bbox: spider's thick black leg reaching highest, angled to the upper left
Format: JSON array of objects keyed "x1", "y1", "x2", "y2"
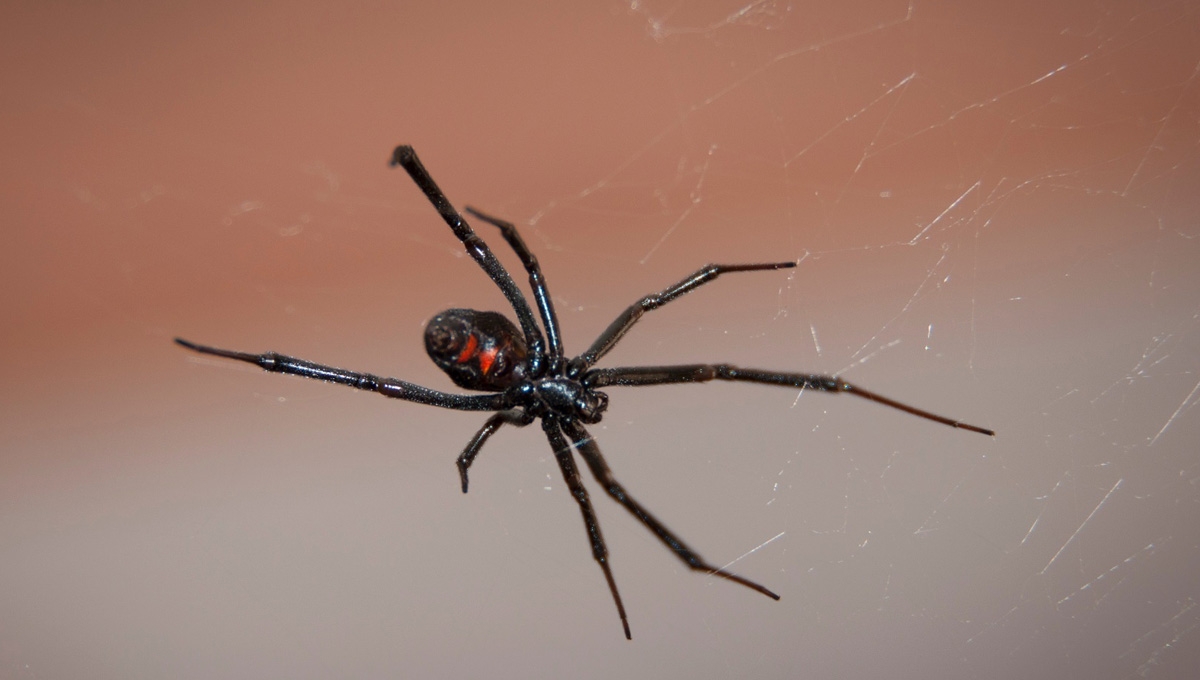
[{"x1": 391, "y1": 144, "x2": 545, "y2": 375}]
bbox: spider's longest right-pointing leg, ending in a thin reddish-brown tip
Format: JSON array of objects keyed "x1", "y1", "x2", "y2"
[{"x1": 582, "y1": 363, "x2": 996, "y2": 437}]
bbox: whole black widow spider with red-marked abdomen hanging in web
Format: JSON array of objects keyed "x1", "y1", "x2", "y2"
[{"x1": 175, "y1": 145, "x2": 995, "y2": 639}]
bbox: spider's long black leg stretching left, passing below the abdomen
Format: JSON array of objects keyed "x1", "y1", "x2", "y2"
[{"x1": 175, "y1": 338, "x2": 512, "y2": 411}]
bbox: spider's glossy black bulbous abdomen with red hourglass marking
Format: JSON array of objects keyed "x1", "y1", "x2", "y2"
[{"x1": 425, "y1": 309, "x2": 528, "y2": 392}]
